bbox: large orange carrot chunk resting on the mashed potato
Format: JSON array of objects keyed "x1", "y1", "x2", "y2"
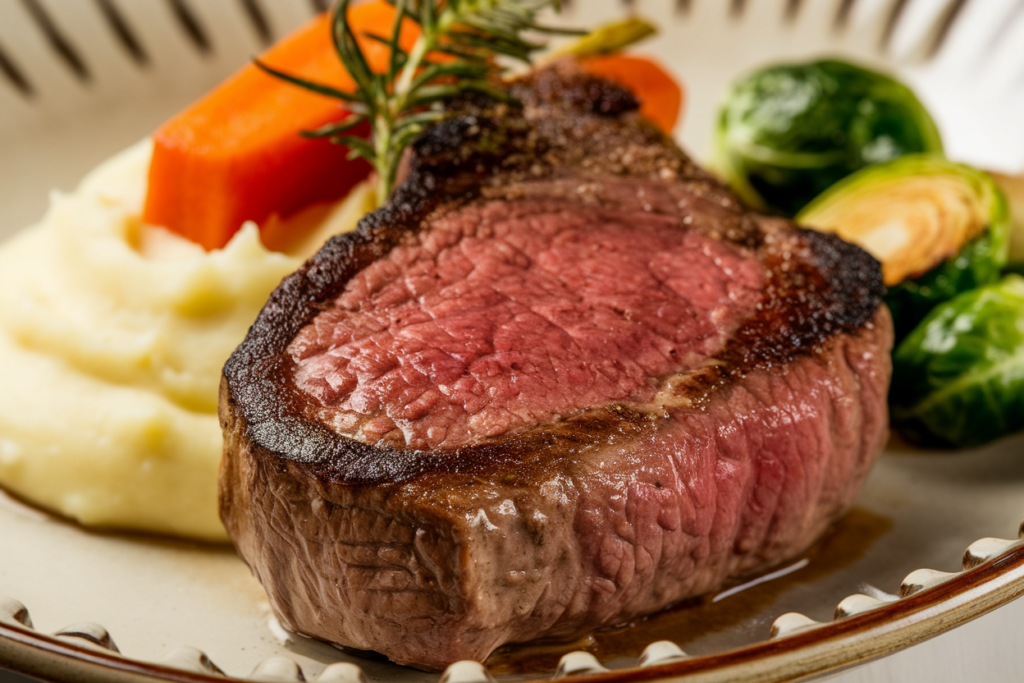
[{"x1": 142, "y1": 0, "x2": 416, "y2": 250}]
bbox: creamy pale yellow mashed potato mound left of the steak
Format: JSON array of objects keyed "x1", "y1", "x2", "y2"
[{"x1": 0, "y1": 142, "x2": 373, "y2": 541}]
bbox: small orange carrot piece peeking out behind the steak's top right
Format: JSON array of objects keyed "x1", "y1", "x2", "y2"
[{"x1": 580, "y1": 54, "x2": 683, "y2": 133}]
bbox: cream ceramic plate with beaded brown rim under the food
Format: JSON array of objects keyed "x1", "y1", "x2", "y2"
[{"x1": 0, "y1": 0, "x2": 1024, "y2": 683}]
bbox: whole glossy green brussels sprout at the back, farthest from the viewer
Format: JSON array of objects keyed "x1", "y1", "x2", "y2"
[{"x1": 715, "y1": 60, "x2": 942, "y2": 216}]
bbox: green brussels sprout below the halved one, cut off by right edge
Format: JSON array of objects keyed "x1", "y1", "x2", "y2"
[{"x1": 889, "y1": 274, "x2": 1024, "y2": 446}]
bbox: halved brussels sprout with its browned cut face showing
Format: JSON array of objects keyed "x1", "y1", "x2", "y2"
[{"x1": 797, "y1": 155, "x2": 1010, "y2": 339}]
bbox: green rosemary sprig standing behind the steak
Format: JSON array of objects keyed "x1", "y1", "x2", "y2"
[{"x1": 256, "y1": 0, "x2": 580, "y2": 204}]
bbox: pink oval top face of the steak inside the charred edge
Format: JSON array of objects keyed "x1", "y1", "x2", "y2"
[{"x1": 289, "y1": 200, "x2": 766, "y2": 449}]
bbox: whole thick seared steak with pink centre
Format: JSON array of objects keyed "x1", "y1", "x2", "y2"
[{"x1": 220, "y1": 62, "x2": 892, "y2": 669}]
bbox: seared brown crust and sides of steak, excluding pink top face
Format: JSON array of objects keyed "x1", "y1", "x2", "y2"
[{"x1": 221, "y1": 63, "x2": 891, "y2": 668}]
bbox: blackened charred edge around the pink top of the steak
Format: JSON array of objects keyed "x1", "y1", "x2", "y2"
[{"x1": 221, "y1": 60, "x2": 885, "y2": 484}]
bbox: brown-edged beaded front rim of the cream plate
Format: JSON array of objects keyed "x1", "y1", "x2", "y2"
[{"x1": 6, "y1": 539, "x2": 1024, "y2": 683}]
